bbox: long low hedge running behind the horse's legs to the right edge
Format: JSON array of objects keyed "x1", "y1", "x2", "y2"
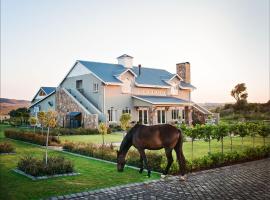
[{"x1": 63, "y1": 142, "x2": 270, "y2": 174}]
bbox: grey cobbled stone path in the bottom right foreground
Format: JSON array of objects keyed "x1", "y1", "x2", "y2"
[{"x1": 48, "y1": 158, "x2": 270, "y2": 200}]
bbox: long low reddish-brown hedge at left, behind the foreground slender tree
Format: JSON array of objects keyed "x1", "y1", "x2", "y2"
[{"x1": 4, "y1": 129, "x2": 60, "y2": 146}]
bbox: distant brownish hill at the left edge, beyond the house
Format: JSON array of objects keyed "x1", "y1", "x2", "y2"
[{"x1": 0, "y1": 98, "x2": 31, "y2": 115}]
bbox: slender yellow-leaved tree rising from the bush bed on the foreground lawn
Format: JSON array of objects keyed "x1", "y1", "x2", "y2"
[{"x1": 45, "y1": 110, "x2": 57, "y2": 165}]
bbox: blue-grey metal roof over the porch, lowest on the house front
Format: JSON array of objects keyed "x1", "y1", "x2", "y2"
[{"x1": 133, "y1": 95, "x2": 191, "y2": 104}]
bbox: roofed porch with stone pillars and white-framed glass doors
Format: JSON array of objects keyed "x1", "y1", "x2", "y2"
[{"x1": 132, "y1": 96, "x2": 193, "y2": 125}]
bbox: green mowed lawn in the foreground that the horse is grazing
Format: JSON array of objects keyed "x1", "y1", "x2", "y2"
[{"x1": 0, "y1": 127, "x2": 159, "y2": 200}]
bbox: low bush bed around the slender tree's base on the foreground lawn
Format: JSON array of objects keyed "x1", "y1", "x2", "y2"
[{"x1": 17, "y1": 156, "x2": 74, "y2": 177}]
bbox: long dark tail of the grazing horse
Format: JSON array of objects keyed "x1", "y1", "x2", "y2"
[{"x1": 176, "y1": 128, "x2": 186, "y2": 176}]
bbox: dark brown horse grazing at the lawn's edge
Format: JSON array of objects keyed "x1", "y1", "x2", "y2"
[{"x1": 117, "y1": 124, "x2": 186, "y2": 177}]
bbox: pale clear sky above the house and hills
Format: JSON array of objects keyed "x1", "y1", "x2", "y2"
[{"x1": 1, "y1": 0, "x2": 270, "y2": 103}]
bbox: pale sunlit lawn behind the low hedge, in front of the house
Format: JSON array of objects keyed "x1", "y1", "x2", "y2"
[{"x1": 60, "y1": 130, "x2": 270, "y2": 160}]
